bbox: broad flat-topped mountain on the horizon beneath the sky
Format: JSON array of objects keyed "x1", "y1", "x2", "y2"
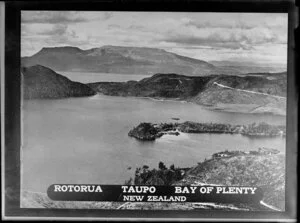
[{"x1": 22, "y1": 46, "x2": 239, "y2": 76}]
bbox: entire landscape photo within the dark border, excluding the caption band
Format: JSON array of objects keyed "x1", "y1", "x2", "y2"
[{"x1": 20, "y1": 10, "x2": 288, "y2": 212}]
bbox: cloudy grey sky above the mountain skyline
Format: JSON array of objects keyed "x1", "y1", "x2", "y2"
[{"x1": 21, "y1": 11, "x2": 288, "y2": 65}]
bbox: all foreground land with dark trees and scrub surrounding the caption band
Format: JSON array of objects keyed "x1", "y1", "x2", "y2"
[{"x1": 21, "y1": 148, "x2": 285, "y2": 211}]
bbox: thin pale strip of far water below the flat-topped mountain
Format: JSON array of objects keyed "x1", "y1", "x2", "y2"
[{"x1": 57, "y1": 71, "x2": 152, "y2": 83}]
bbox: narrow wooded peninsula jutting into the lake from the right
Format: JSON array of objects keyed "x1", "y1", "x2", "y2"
[{"x1": 128, "y1": 122, "x2": 286, "y2": 141}]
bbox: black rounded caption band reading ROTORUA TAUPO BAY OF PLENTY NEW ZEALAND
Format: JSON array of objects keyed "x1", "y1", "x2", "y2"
[{"x1": 47, "y1": 184, "x2": 263, "y2": 203}]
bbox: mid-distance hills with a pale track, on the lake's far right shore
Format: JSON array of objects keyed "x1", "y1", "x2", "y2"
[{"x1": 87, "y1": 73, "x2": 287, "y2": 115}]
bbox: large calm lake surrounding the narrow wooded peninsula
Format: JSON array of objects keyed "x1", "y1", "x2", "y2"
[{"x1": 21, "y1": 95, "x2": 285, "y2": 192}]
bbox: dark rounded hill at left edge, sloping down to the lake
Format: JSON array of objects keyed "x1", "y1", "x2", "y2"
[{"x1": 21, "y1": 65, "x2": 95, "y2": 99}]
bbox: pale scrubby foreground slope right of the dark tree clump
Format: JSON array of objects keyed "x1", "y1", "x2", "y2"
[{"x1": 178, "y1": 154, "x2": 285, "y2": 210}]
